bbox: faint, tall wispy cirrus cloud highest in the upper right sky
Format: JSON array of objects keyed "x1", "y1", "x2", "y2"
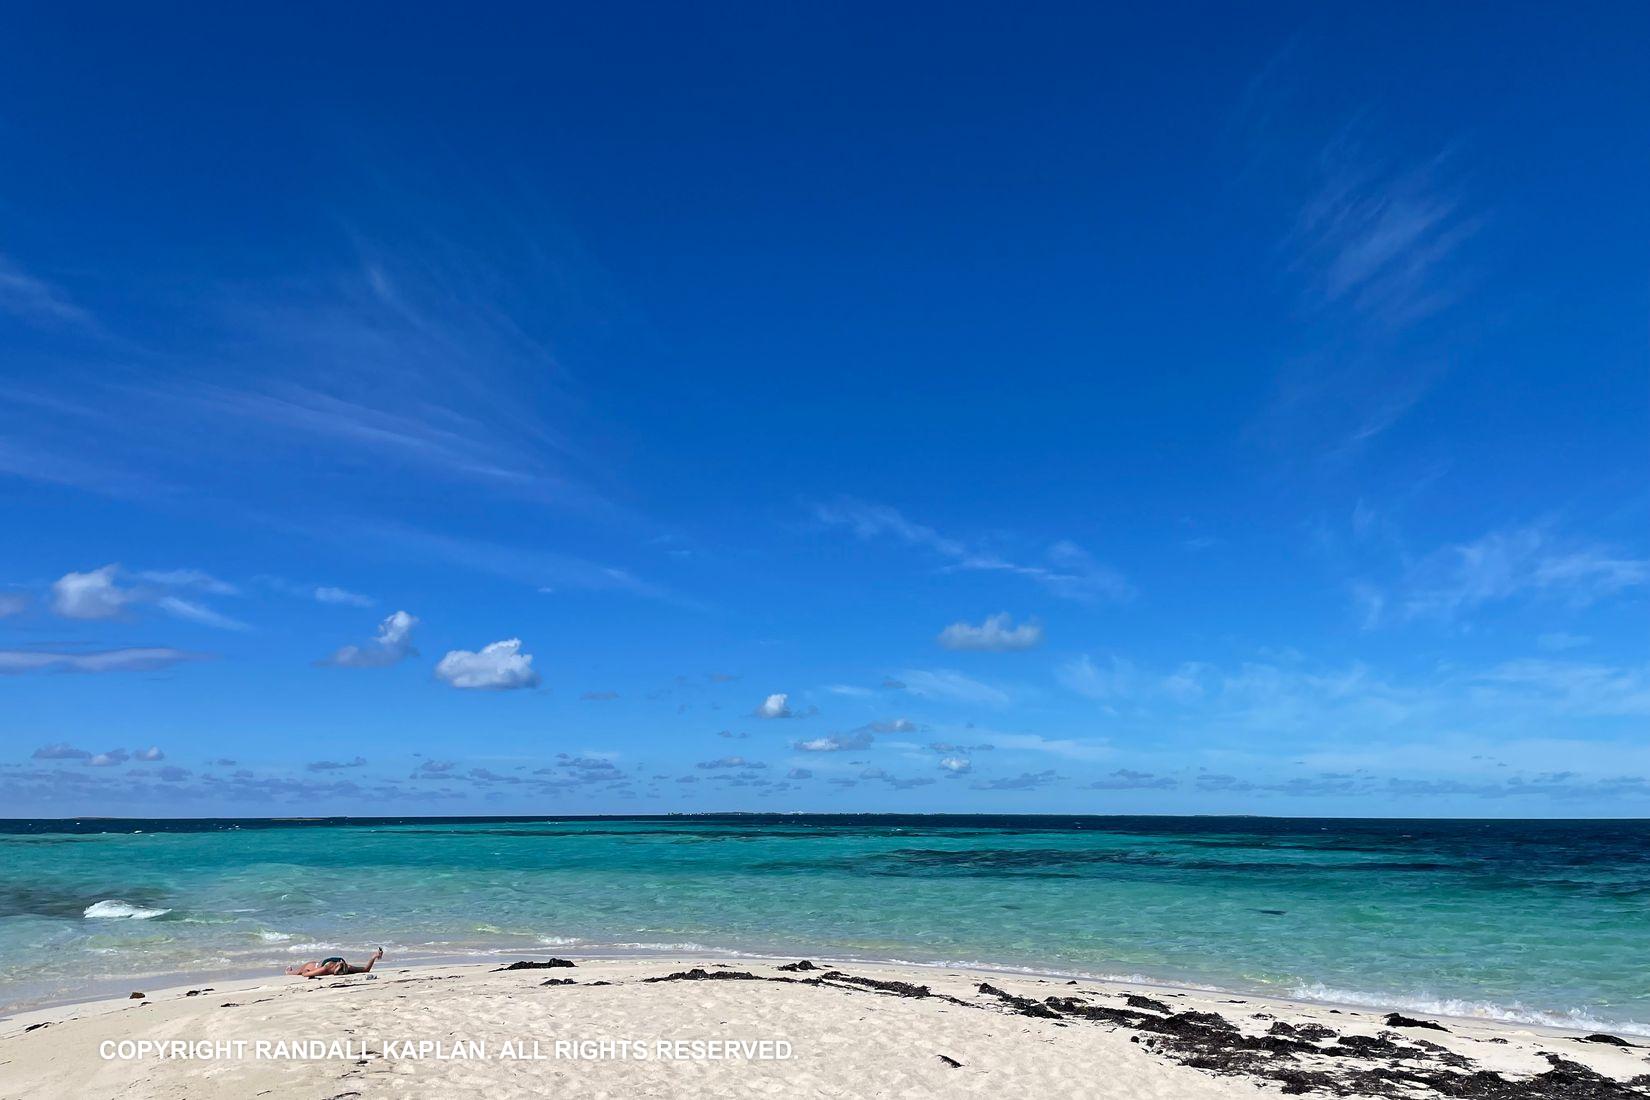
[{"x1": 1234, "y1": 49, "x2": 1490, "y2": 465}]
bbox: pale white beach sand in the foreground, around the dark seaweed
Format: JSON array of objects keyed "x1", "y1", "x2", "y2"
[{"x1": 0, "y1": 958, "x2": 1650, "y2": 1100}]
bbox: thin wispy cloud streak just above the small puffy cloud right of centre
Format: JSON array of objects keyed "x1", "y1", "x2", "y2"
[{"x1": 813, "y1": 496, "x2": 1134, "y2": 600}]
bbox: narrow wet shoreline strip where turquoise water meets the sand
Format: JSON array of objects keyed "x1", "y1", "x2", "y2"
[{"x1": 0, "y1": 943, "x2": 1650, "y2": 1047}]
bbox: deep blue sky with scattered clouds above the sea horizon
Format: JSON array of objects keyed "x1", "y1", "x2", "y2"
[{"x1": 0, "y1": 5, "x2": 1650, "y2": 816}]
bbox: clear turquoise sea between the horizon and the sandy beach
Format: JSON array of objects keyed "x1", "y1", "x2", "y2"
[{"x1": 0, "y1": 816, "x2": 1650, "y2": 1034}]
